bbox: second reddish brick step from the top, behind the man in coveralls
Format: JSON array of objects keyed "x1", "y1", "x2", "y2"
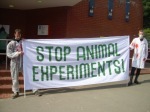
[{"x1": 0, "y1": 77, "x2": 24, "y2": 85}]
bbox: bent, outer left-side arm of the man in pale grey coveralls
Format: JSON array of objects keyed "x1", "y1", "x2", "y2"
[{"x1": 6, "y1": 41, "x2": 21, "y2": 59}]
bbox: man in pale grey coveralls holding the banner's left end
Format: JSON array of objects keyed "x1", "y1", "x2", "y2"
[{"x1": 6, "y1": 29, "x2": 41, "y2": 99}]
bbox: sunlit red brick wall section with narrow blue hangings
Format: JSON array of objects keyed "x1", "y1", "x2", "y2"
[{"x1": 67, "y1": 0, "x2": 143, "y2": 38}]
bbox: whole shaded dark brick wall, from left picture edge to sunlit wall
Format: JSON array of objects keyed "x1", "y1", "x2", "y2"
[{"x1": 0, "y1": 7, "x2": 68, "y2": 38}]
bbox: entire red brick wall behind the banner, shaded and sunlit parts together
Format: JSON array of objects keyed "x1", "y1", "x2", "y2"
[{"x1": 0, "y1": 0, "x2": 143, "y2": 38}]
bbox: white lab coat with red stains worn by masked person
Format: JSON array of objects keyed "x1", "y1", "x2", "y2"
[{"x1": 130, "y1": 38, "x2": 148, "y2": 68}]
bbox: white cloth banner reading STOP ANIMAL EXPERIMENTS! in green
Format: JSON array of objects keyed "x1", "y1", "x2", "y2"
[{"x1": 23, "y1": 36, "x2": 129, "y2": 90}]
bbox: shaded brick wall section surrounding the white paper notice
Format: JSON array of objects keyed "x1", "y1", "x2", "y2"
[{"x1": 26, "y1": 7, "x2": 68, "y2": 38}]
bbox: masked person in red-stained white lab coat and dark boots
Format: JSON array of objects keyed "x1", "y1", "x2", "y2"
[{"x1": 128, "y1": 30, "x2": 148, "y2": 86}]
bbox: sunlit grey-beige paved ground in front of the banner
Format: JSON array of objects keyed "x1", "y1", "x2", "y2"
[{"x1": 0, "y1": 75, "x2": 150, "y2": 112}]
